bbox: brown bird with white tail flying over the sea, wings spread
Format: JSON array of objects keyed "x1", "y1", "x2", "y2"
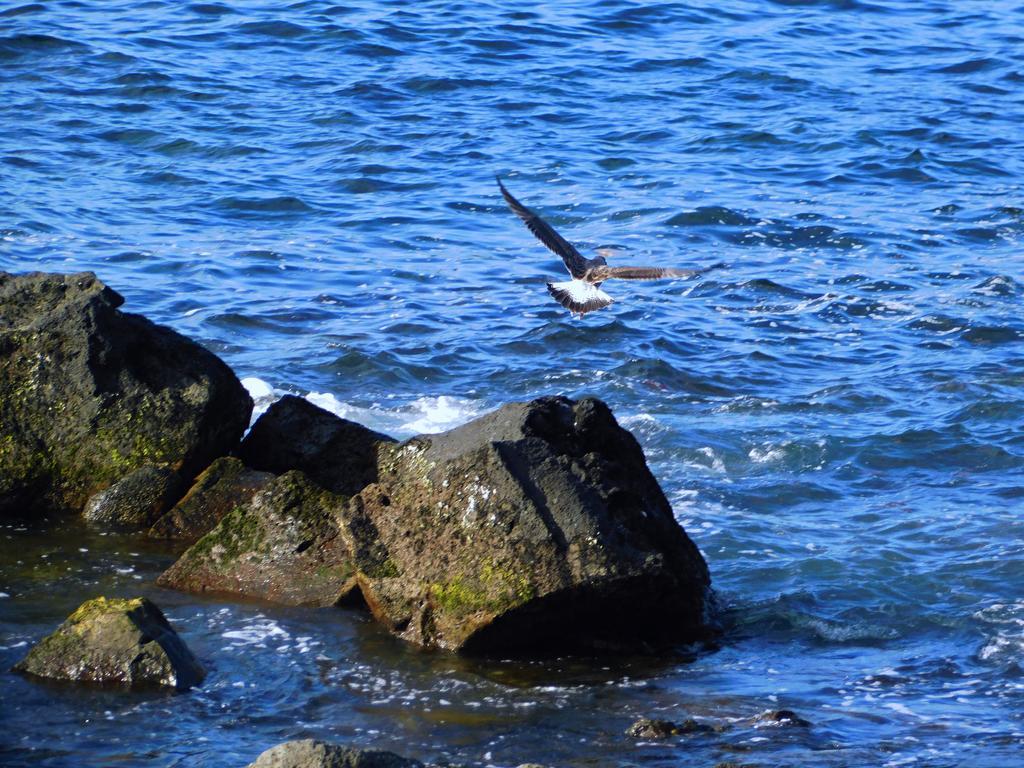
[{"x1": 495, "y1": 176, "x2": 707, "y2": 317}]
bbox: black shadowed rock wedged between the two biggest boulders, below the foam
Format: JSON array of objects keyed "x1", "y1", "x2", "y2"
[{"x1": 238, "y1": 395, "x2": 394, "y2": 496}]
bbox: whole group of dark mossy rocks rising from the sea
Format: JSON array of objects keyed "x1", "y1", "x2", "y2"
[{"x1": 0, "y1": 273, "x2": 715, "y2": 765}]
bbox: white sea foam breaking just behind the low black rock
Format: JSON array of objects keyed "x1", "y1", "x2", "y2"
[{"x1": 242, "y1": 377, "x2": 486, "y2": 438}]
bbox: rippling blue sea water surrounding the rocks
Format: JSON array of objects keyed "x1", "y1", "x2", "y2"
[{"x1": 0, "y1": 0, "x2": 1024, "y2": 768}]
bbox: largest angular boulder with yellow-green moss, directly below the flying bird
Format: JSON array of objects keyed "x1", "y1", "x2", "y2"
[{"x1": 364, "y1": 397, "x2": 710, "y2": 654}]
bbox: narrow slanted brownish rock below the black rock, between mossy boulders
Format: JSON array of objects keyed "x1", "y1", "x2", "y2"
[{"x1": 148, "y1": 457, "x2": 273, "y2": 542}]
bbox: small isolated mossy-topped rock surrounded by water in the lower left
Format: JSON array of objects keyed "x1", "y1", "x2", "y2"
[{"x1": 14, "y1": 597, "x2": 206, "y2": 690}]
